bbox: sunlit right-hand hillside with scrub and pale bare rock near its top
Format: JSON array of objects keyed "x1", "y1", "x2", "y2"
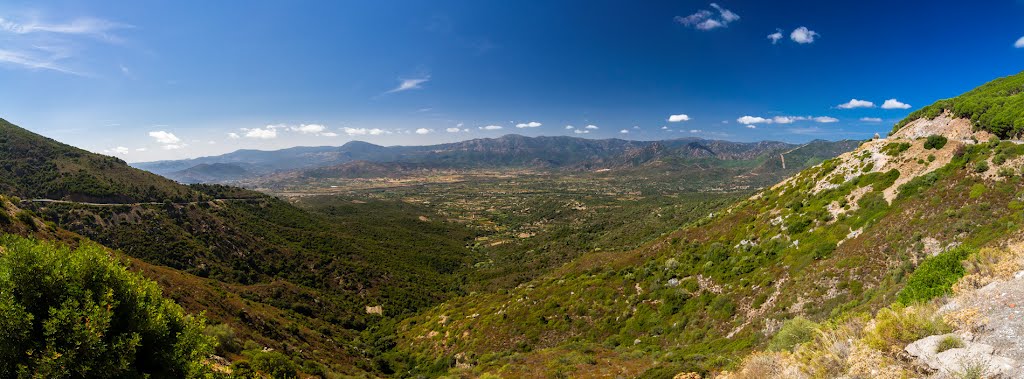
[{"x1": 391, "y1": 75, "x2": 1024, "y2": 377}]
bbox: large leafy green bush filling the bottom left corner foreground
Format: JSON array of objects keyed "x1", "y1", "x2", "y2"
[{"x1": 0, "y1": 236, "x2": 212, "y2": 378}]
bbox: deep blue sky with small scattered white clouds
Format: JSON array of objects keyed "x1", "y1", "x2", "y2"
[{"x1": 0, "y1": 0, "x2": 1024, "y2": 162}]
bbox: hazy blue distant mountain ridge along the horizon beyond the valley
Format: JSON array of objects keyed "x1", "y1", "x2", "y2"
[{"x1": 133, "y1": 134, "x2": 855, "y2": 182}]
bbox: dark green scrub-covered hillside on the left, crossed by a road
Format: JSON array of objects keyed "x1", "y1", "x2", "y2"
[{"x1": 0, "y1": 118, "x2": 481, "y2": 374}]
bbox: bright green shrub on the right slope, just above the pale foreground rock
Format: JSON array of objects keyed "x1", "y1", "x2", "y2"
[{"x1": 897, "y1": 248, "x2": 973, "y2": 304}]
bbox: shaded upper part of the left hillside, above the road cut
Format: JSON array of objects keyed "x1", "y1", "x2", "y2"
[{"x1": 0, "y1": 119, "x2": 199, "y2": 202}]
